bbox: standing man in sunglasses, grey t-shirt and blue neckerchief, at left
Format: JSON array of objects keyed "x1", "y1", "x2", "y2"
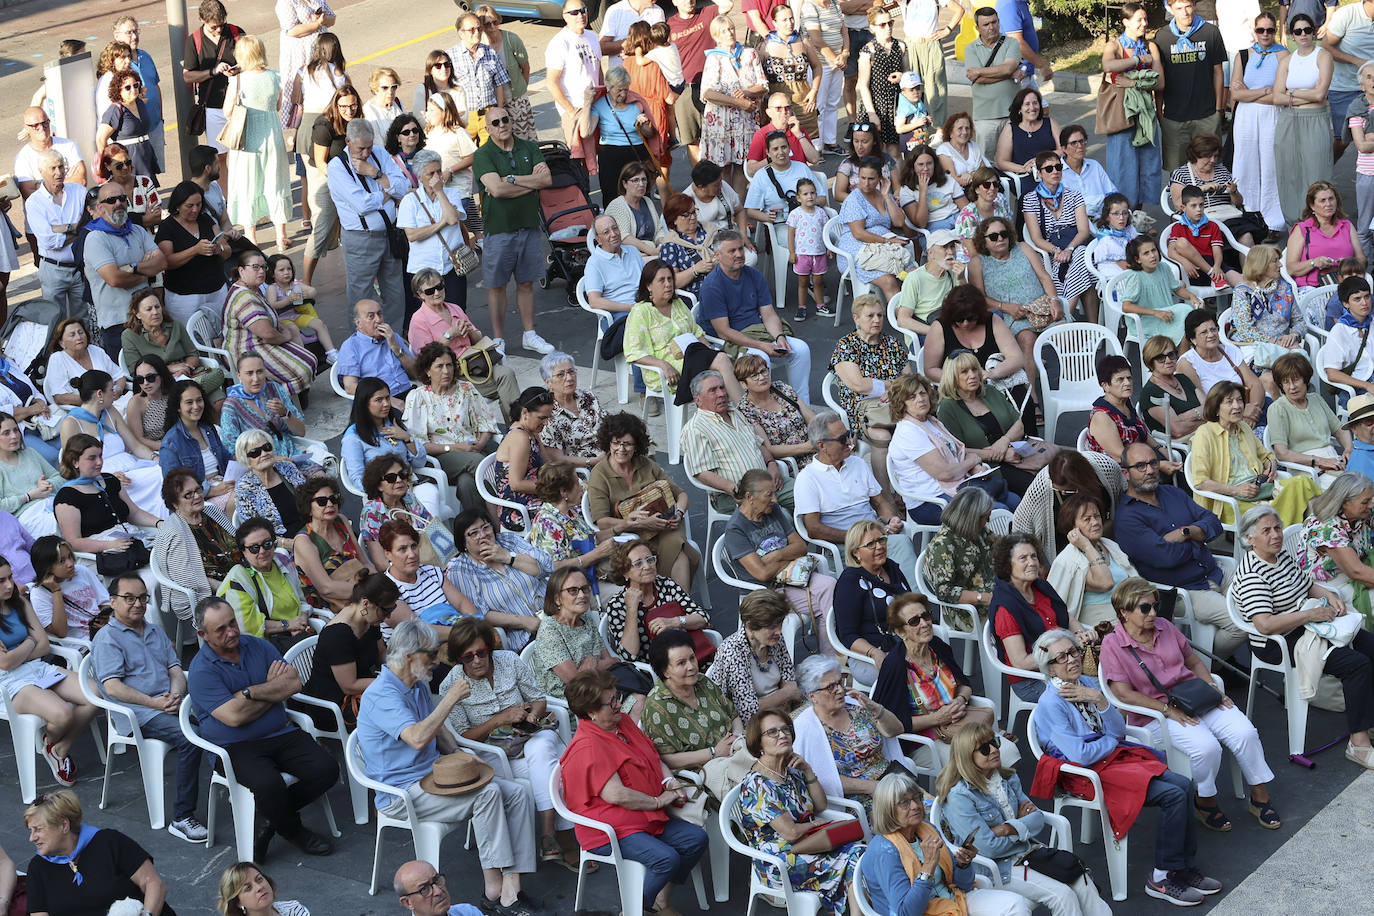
[{"x1": 84, "y1": 181, "x2": 168, "y2": 353}]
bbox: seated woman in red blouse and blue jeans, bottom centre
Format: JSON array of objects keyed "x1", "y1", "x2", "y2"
[{"x1": 561, "y1": 670, "x2": 709, "y2": 915}]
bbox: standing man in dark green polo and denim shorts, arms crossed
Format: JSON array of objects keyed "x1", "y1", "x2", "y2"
[{"x1": 473, "y1": 106, "x2": 554, "y2": 356}]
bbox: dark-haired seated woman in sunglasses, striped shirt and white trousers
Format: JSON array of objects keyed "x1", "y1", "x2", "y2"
[{"x1": 438, "y1": 617, "x2": 579, "y2": 872}]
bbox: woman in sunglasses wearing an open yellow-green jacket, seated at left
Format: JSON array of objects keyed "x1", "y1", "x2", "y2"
[{"x1": 216, "y1": 518, "x2": 313, "y2": 652}]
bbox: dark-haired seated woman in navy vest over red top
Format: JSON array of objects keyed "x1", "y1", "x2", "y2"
[{"x1": 991, "y1": 531, "x2": 1069, "y2": 700}]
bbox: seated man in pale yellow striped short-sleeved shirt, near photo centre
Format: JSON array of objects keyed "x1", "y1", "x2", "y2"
[{"x1": 682, "y1": 369, "x2": 793, "y2": 514}]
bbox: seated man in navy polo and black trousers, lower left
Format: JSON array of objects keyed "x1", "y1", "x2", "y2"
[{"x1": 190, "y1": 597, "x2": 339, "y2": 864}]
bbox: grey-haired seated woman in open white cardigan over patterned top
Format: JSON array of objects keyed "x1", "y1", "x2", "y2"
[{"x1": 796, "y1": 655, "x2": 914, "y2": 810}]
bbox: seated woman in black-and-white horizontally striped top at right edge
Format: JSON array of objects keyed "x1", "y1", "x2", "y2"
[{"x1": 1231, "y1": 505, "x2": 1374, "y2": 769}]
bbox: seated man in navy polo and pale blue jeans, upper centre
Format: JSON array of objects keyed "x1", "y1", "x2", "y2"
[{"x1": 701, "y1": 229, "x2": 811, "y2": 404}]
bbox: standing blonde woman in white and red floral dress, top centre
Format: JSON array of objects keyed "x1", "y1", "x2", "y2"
[{"x1": 701, "y1": 16, "x2": 768, "y2": 192}]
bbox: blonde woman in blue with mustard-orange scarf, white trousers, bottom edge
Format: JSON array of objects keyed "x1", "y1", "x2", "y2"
[{"x1": 859, "y1": 773, "x2": 1031, "y2": 916}]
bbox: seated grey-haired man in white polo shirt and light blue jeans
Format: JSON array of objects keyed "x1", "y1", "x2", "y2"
[{"x1": 793, "y1": 411, "x2": 916, "y2": 582}]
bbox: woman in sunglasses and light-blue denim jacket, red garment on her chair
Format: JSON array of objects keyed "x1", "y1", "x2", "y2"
[{"x1": 1031, "y1": 629, "x2": 1221, "y2": 906}]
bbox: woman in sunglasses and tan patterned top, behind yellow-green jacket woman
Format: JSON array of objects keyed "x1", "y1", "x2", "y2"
[{"x1": 291, "y1": 477, "x2": 372, "y2": 611}]
